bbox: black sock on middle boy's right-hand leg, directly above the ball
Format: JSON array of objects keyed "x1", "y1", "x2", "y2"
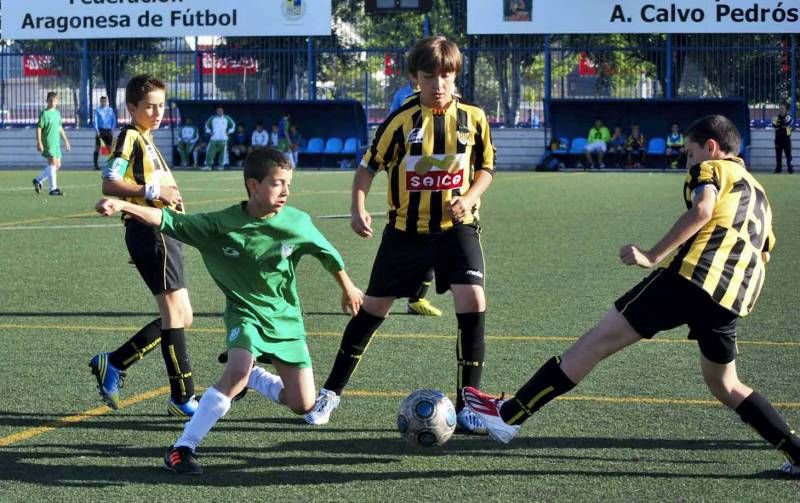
[{"x1": 456, "y1": 313, "x2": 486, "y2": 411}]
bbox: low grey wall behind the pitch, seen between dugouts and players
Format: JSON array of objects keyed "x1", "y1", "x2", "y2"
[{"x1": 0, "y1": 128, "x2": 788, "y2": 170}]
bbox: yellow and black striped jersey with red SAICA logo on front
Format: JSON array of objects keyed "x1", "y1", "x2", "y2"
[{"x1": 361, "y1": 93, "x2": 495, "y2": 233}]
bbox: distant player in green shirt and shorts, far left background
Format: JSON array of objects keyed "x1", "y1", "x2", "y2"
[{"x1": 33, "y1": 91, "x2": 72, "y2": 196}]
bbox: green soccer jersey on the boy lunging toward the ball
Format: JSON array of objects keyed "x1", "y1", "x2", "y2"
[{"x1": 161, "y1": 202, "x2": 344, "y2": 340}]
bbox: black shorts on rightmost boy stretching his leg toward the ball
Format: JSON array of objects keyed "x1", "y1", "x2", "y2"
[{"x1": 614, "y1": 269, "x2": 739, "y2": 364}]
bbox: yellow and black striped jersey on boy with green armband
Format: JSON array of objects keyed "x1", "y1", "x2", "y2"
[{"x1": 103, "y1": 125, "x2": 184, "y2": 213}]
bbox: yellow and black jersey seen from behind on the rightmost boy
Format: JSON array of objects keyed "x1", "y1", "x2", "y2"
[{"x1": 669, "y1": 158, "x2": 775, "y2": 316}]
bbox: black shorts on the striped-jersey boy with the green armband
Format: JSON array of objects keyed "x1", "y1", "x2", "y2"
[{"x1": 125, "y1": 219, "x2": 186, "y2": 295}]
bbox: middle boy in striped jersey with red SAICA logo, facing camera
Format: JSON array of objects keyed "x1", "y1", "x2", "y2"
[{"x1": 306, "y1": 37, "x2": 495, "y2": 434}]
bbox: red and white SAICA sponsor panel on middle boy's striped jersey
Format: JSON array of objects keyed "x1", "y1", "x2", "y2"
[{"x1": 406, "y1": 154, "x2": 465, "y2": 192}]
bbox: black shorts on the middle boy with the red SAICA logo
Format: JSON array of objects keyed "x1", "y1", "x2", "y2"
[{"x1": 367, "y1": 224, "x2": 485, "y2": 297}]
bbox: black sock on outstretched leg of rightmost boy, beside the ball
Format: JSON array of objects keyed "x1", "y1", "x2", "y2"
[{"x1": 500, "y1": 356, "x2": 575, "y2": 424}]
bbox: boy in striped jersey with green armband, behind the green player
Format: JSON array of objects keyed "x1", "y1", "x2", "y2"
[{"x1": 89, "y1": 75, "x2": 197, "y2": 417}]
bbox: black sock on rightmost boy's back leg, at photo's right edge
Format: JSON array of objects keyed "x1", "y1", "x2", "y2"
[{"x1": 736, "y1": 391, "x2": 800, "y2": 466}]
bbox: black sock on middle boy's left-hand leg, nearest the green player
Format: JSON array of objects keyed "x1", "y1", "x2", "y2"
[{"x1": 323, "y1": 308, "x2": 385, "y2": 395}]
